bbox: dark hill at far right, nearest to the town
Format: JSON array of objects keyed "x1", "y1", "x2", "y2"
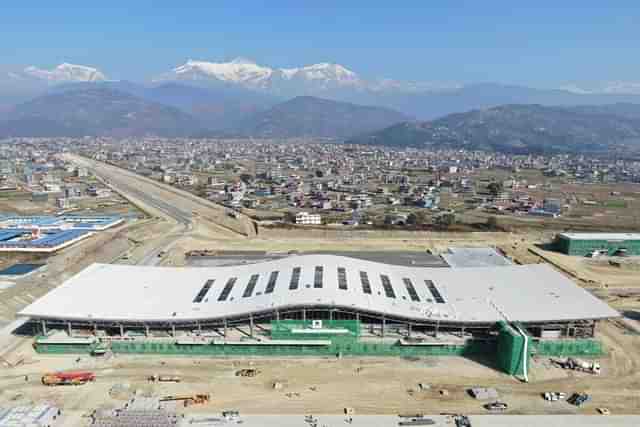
[{"x1": 348, "y1": 104, "x2": 640, "y2": 153}]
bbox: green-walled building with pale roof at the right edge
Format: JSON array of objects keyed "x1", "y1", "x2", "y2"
[{"x1": 553, "y1": 233, "x2": 640, "y2": 256}]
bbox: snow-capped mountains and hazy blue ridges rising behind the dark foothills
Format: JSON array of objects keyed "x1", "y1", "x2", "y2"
[{"x1": 8, "y1": 58, "x2": 640, "y2": 120}]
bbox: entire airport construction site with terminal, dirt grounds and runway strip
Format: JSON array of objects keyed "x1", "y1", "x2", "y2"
[{"x1": 0, "y1": 158, "x2": 640, "y2": 427}]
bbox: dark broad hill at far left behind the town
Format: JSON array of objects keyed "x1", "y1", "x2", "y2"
[{"x1": 0, "y1": 86, "x2": 202, "y2": 137}]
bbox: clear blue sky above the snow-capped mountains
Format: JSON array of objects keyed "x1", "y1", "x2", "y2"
[{"x1": 0, "y1": 0, "x2": 640, "y2": 87}]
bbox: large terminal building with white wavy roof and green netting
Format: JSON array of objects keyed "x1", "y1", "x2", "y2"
[{"x1": 20, "y1": 255, "x2": 618, "y2": 372}]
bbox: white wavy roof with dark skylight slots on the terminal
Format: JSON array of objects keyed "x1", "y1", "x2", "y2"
[{"x1": 20, "y1": 255, "x2": 619, "y2": 323}]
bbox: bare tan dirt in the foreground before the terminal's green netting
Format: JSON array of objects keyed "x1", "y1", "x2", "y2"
[{"x1": 0, "y1": 322, "x2": 640, "y2": 422}]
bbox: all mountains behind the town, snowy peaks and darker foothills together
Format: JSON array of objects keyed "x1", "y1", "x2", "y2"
[{"x1": 0, "y1": 58, "x2": 640, "y2": 152}]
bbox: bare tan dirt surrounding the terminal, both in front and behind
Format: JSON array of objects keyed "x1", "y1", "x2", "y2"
[{"x1": 0, "y1": 159, "x2": 640, "y2": 425}]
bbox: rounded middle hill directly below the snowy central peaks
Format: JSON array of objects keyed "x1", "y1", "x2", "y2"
[{"x1": 235, "y1": 96, "x2": 409, "y2": 138}]
